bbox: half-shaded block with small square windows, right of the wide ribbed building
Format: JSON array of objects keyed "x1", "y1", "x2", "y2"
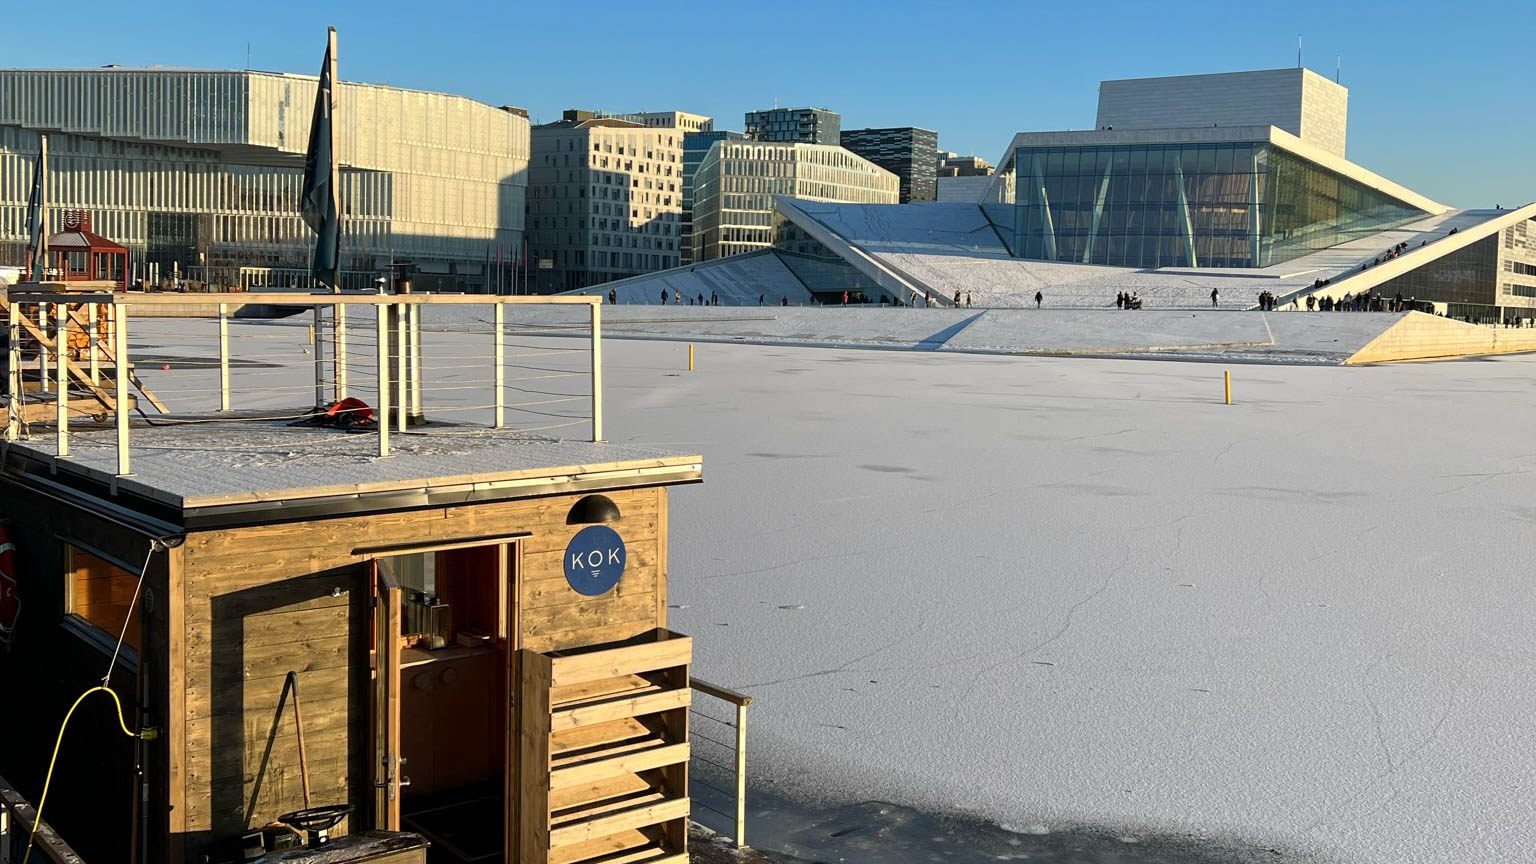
[{"x1": 528, "y1": 118, "x2": 682, "y2": 294}]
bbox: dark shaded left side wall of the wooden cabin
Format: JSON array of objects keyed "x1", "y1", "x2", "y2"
[{"x1": 0, "y1": 483, "x2": 177, "y2": 862}]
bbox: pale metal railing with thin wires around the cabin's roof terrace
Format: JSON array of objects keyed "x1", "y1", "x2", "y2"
[{"x1": 5, "y1": 283, "x2": 604, "y2": 475}]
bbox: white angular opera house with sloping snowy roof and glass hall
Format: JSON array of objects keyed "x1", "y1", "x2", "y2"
[{"x1": 592, "y1": 69, "x2": 1536, "y2": 323}]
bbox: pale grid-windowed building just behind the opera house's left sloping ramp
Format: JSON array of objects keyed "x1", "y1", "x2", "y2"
[{"x1": 693, "y1": 141, "x2": 900, "y2": 261}]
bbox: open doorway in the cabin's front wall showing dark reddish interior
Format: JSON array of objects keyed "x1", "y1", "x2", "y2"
[{"x1": 375, "y1": 540, "x2": 516, "y2": 864}]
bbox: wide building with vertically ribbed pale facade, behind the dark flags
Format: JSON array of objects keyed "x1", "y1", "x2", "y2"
[{"x1": 0, "y1": 68, "x2": 528, "y2": 291}]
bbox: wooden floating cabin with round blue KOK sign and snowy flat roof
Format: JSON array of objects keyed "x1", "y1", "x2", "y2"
[{"x1": 0, "y1": 289, "x2": 702, "y2": 864}]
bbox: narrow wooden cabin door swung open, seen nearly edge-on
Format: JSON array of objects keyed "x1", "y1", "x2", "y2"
[{"x1": 373, "y1": 566, "x2": 404, "y2": 832}]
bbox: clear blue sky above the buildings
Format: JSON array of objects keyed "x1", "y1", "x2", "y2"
[{"x1": 12, "y1": 0, "x2": 1536, "y2": 206}]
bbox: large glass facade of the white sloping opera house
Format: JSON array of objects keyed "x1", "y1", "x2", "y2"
[{"x1": 992, "y1": 141, "x2": 1427, "y2": 268}]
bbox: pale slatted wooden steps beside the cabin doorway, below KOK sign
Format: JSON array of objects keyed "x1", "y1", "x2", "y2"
[{"x1": 518, "y1": 630, "x2": 693, "y2": 864}]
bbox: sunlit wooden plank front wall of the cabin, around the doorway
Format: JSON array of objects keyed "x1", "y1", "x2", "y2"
[{"x1": 174, "y1": 487, "x2": 667, "y2": 861}]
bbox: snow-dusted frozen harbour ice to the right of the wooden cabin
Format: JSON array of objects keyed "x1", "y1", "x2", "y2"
[{"x1": 586, "y1": 341, "x2": 1536, "y2": 864}]
